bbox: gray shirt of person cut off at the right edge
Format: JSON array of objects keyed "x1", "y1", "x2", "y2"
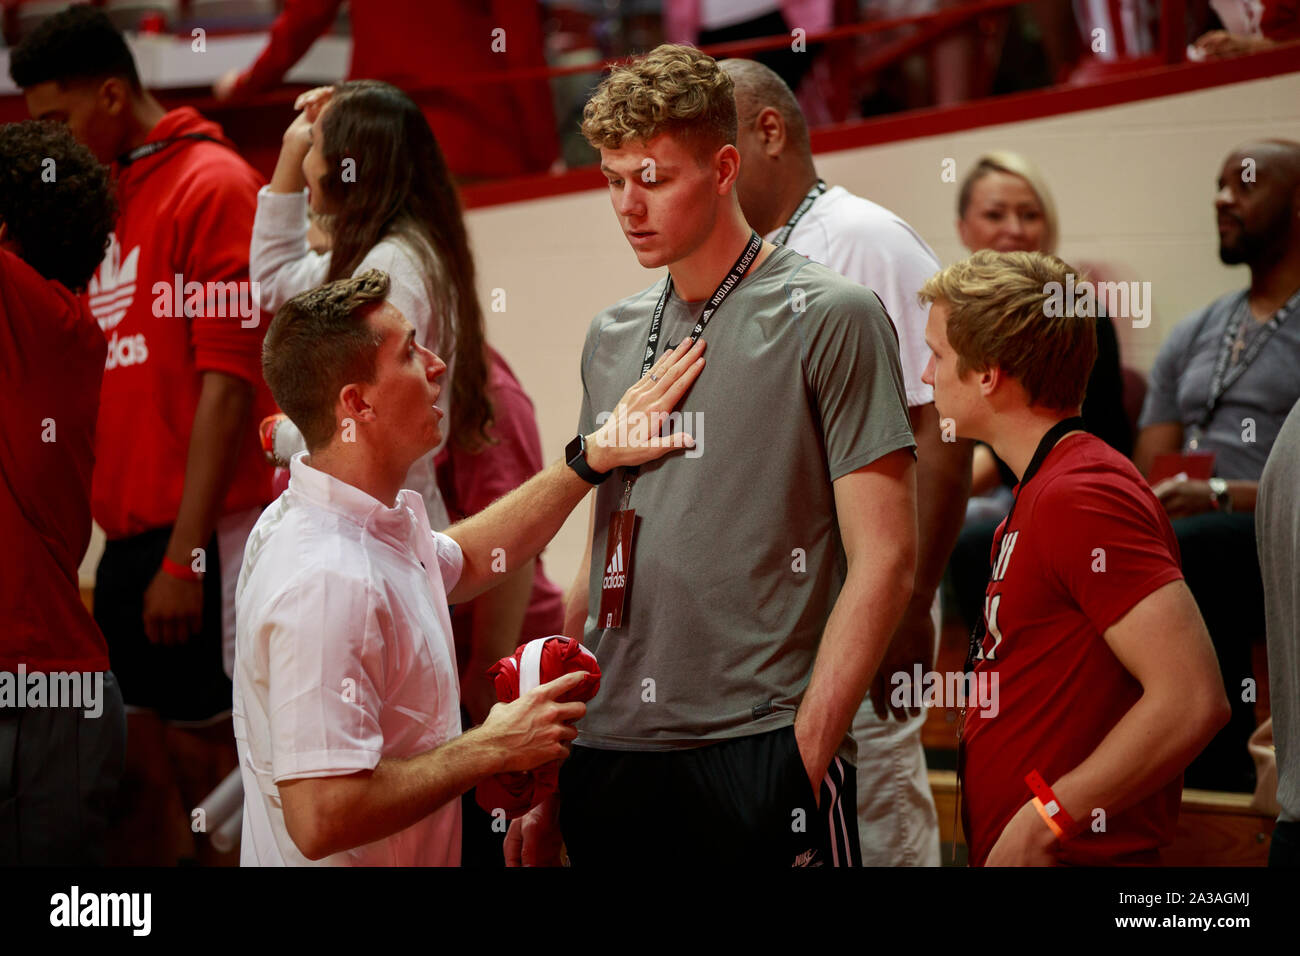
[{"x1": 1255, "y1": 395, "x2": 1300, "y2": 822}]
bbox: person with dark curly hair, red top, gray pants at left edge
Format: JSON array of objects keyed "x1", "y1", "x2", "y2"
[{"x1": 0, "y1": 122, "x2": 126, "y2": 866}]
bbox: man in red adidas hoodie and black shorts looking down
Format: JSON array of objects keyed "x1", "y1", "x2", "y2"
[{"x1": 9, "y1": 7, "x2": 272, "y2": 862}]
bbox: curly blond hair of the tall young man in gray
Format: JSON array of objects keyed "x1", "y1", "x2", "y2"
[{"x1": 582, "y1": 43, "x2": 736, "y2": 153}]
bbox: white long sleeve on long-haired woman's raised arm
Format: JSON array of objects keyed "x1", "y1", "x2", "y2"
[{"x1": 248, "y1": 186, "x2": 329, "y2": 312}]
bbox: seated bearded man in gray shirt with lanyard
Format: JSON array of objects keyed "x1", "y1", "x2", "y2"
[{"x1": 1134, "y1": 139, "x2": 1300, "y2": 791}]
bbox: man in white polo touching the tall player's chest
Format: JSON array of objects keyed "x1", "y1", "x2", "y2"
[{"x1": 234, "y1": 271, "x2": 703, "y2": 865}]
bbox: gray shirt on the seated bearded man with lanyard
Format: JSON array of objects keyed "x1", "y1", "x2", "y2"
[{"x1": 1138, "y1": 283, "x2": 1300, "y2": 481}]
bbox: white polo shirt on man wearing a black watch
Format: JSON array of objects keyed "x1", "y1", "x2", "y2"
[{"x1": 234, "y1": 454, "x2": 463, "y2": 866}]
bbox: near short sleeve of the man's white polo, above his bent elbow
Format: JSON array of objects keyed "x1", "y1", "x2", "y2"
[{"x1": 261, "y1": 568, "x2": 385, "y2": 783}]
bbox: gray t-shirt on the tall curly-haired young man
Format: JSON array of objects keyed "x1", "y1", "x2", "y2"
[{"x1": 579, "y1": 248, "x2": 915, "y2": 750}]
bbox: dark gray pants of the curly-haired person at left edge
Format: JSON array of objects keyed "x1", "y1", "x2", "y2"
[{"x1": 0, "y1": 671, "x2": 126, "y2": 866}]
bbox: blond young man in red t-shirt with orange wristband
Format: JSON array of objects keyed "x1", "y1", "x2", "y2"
[{"x1": 920, "y1": 251, "x2": 1229, "y2": 866}]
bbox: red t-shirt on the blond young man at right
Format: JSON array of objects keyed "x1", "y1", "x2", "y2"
[{"x1": 963, "y1": 434, "x2": 1183, "y2": 866}]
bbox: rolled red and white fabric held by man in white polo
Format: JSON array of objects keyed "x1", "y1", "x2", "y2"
[{"x1": 475, "y1": 636, "x2": 601, "y2": 819}]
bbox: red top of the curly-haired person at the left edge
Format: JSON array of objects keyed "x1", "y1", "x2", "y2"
[{"x1": 0, "y1": 250, "x2": 108, "y2": 671}]
